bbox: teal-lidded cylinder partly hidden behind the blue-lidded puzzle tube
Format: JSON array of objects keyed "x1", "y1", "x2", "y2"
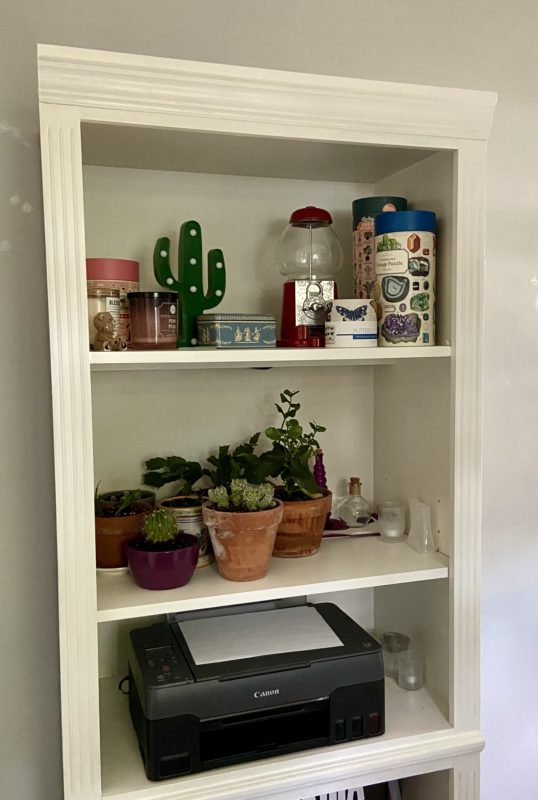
[{"x1": 353, "y1": 195, "x2": 407, "y2": 298}]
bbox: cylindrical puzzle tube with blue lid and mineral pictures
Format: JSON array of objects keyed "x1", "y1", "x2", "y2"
[{"x1": 375, "y1": 211, "x2": 437, "y2": 347}]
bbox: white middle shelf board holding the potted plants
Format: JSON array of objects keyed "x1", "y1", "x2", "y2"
[{"x1": 97, "y1": 537, "x2": 448, "y2": 622}]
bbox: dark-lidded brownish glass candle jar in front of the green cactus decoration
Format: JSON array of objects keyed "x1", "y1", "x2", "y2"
[{"x1": 127, "y1": 292, "x2": 178, "y2": 350}]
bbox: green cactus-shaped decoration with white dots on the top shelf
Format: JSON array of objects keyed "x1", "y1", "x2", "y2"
[{"x1": 153, "y1": 220, "x2": 226, "y2": 347}]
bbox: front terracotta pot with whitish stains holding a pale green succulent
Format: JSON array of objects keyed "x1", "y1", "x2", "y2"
[{"x1": 202, "y1": 500, "x2": 283, "y2": 581}]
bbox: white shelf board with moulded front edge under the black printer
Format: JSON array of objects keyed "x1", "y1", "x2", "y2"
[{"x1": 100, "y1": 678, "x2": 483, "y2": 800}]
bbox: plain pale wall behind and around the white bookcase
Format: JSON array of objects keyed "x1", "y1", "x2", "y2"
[{"x1": 0, "y1": 0, "x2": 538, "y2": 800}]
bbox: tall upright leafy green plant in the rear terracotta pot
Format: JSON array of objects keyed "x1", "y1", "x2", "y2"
[{"x1": 258, "y1": 389, "x2": 325, "y2": 500}]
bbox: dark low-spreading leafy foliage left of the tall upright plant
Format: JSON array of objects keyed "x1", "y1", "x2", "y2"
[{"x1": 143, "y1": 433, "x2": 260, "y2": 494}]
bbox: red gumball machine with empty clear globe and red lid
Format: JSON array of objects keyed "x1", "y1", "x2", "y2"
[{"x1": 277, "y1": 206, "x2": 343, "y2": 347}]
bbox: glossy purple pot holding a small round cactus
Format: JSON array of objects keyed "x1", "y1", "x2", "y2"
[{"x1": 127, "y1": 533, "x2": 200, "y2": 589}]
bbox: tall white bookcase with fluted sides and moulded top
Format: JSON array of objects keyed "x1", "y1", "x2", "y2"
[{"x1": 38, "y1": 45, "x2": 496, "y2": 800}]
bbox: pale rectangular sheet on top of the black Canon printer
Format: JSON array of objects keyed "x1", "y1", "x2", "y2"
[{"x1": 178, "y1": 606, "x2": 343, "y2": 664}]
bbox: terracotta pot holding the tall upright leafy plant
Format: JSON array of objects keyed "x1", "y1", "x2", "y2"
[{"x1": 273, "y1": 492, "x2": 332, "y2": 558}]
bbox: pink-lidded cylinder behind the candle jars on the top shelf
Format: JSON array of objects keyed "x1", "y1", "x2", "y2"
[{"x1": 86, "y1": 258, "x2": 140, "y2": 347}]
